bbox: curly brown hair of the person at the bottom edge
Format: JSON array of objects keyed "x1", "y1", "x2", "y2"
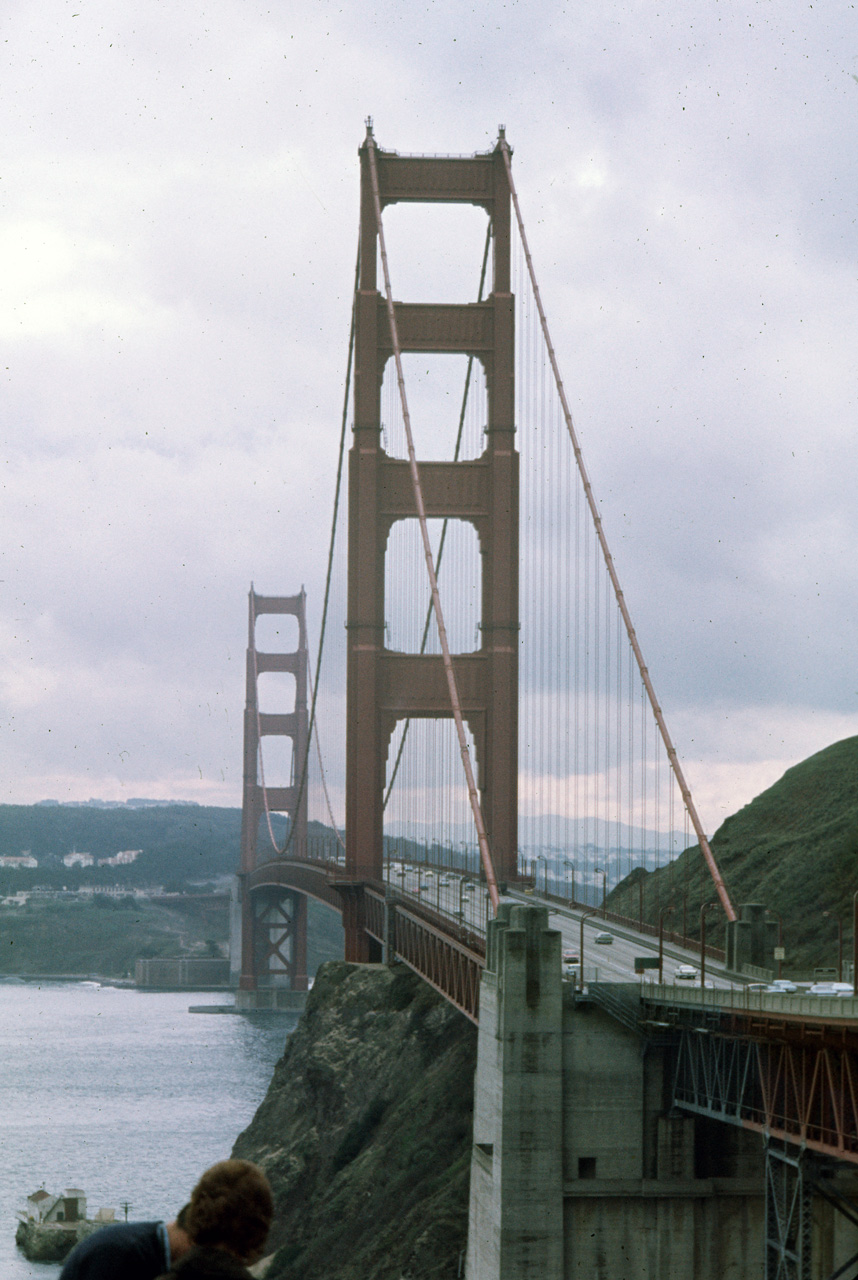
[{"x1": 186, "y1": 1160, "x2": 274, "y2": 1261}]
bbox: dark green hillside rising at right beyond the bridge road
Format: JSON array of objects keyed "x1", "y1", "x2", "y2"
[{"x1": 608, "y1": 737, "x2": 858, "y2": 972}]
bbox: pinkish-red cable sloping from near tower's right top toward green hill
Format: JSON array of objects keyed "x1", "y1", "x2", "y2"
[{"x1": 499, "y1": 136, "x2": 736, "y2": 920}]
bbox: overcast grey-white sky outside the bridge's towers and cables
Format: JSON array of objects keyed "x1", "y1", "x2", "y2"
[{"x1": 0, "y1": 0, "x2": 858, "y2": 829}]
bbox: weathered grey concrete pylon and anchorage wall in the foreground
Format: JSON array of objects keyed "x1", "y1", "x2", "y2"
[{"x1": 467, "y1": 904, "x2": 765, "y2": 1280}]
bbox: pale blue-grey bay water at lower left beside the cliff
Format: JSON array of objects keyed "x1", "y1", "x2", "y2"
[{"x1": 0, "y1": 980, "x2": 296, "y2": 1280}]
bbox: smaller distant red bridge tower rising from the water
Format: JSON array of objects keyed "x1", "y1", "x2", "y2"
[{"x1": 238, "y1": 586, "x2": 309, "y2": 992}]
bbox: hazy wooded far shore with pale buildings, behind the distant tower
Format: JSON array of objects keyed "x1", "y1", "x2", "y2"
[{"x1": 0, "y1": 805, "x2": 343, "y2": 978}]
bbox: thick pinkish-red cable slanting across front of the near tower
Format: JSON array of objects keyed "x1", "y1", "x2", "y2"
[{"x1": 366, "y1": 132, "x2": 499, "y2": 913}]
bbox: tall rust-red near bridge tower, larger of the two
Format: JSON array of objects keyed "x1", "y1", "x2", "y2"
[{"x1": 338, "y1": 128, "x2": 519, "y2": 960}]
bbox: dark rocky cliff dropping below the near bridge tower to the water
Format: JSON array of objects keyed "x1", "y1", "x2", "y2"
[{"x1": 233, "y1": 963, "x2": 476, "y2": 1280}]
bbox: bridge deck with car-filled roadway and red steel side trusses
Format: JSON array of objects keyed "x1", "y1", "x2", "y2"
[{"x1": 251, "y1": 860, "x2": 858, "y2": 1164}]
